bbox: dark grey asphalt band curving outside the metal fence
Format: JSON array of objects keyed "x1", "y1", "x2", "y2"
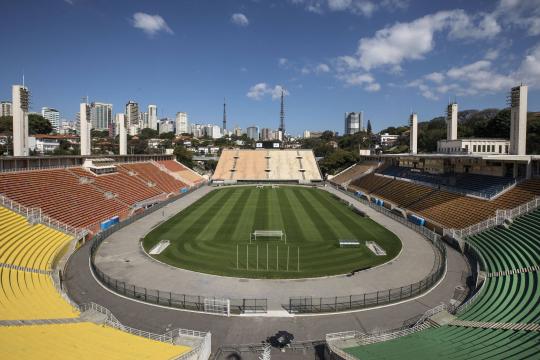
[{"x1": 64, "y1": 187, "x2": 469, "y2": 358}]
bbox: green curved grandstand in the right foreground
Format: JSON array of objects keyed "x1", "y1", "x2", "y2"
[{"x1": 330, "y1": 210, "x2": 540, "y2": 360}]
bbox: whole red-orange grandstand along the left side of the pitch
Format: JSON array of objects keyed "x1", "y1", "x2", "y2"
[{"x1": 0, "y1": 160, "x2": 204, "y2": 232}]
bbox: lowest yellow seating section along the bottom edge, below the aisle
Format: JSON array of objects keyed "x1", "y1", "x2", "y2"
[{"x1": 0, "y1": 322, "x2": 191, "y2": 360}]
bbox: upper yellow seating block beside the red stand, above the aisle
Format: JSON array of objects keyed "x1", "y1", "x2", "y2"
[{"x1": 0, "y1": 207, "x2": 73, "y2": 270}]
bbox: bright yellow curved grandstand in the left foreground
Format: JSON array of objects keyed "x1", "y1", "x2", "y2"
[{"x1": 0, "y1": 201, "x2": 202, "y2": 359}]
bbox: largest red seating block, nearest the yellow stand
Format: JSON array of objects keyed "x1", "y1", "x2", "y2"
[{"x1": 0, "y1": 169, "x2": 129, "y2": 228}]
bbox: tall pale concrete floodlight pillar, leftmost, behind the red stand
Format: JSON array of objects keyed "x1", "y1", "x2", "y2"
[{"x1": 12, "y1": 85, "x2": 30, "y2": 156}]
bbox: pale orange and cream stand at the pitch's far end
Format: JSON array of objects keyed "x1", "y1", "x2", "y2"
[{"x1": 212, "y1": 149, "x2": 322, "y2": 183}]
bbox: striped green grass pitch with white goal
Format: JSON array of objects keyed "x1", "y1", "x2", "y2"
[{"x1": 143, "y1": 186, "x2": 401, "y2": 278}]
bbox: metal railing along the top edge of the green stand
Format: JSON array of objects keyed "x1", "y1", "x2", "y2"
[{"x1": 443, "y1": 197, "x2": 540, "y2": 239}]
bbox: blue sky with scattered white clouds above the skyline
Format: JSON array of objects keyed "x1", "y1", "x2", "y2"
[{"x1": 0, "y1": 0, "x2": 540, "y2": 134}]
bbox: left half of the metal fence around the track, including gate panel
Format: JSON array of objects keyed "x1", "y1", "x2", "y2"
[{"x1": 90, "y1": 188, "x2": 268, "y2": 314}]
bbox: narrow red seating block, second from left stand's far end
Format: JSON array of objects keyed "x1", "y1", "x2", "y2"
[{"x1": 117, "y1": 162, "x2": 187, "y2": 194}]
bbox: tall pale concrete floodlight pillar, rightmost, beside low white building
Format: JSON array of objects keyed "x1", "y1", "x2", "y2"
[{"x1": 510, "y1": 84, "x2": 528, "y2": 155}]
